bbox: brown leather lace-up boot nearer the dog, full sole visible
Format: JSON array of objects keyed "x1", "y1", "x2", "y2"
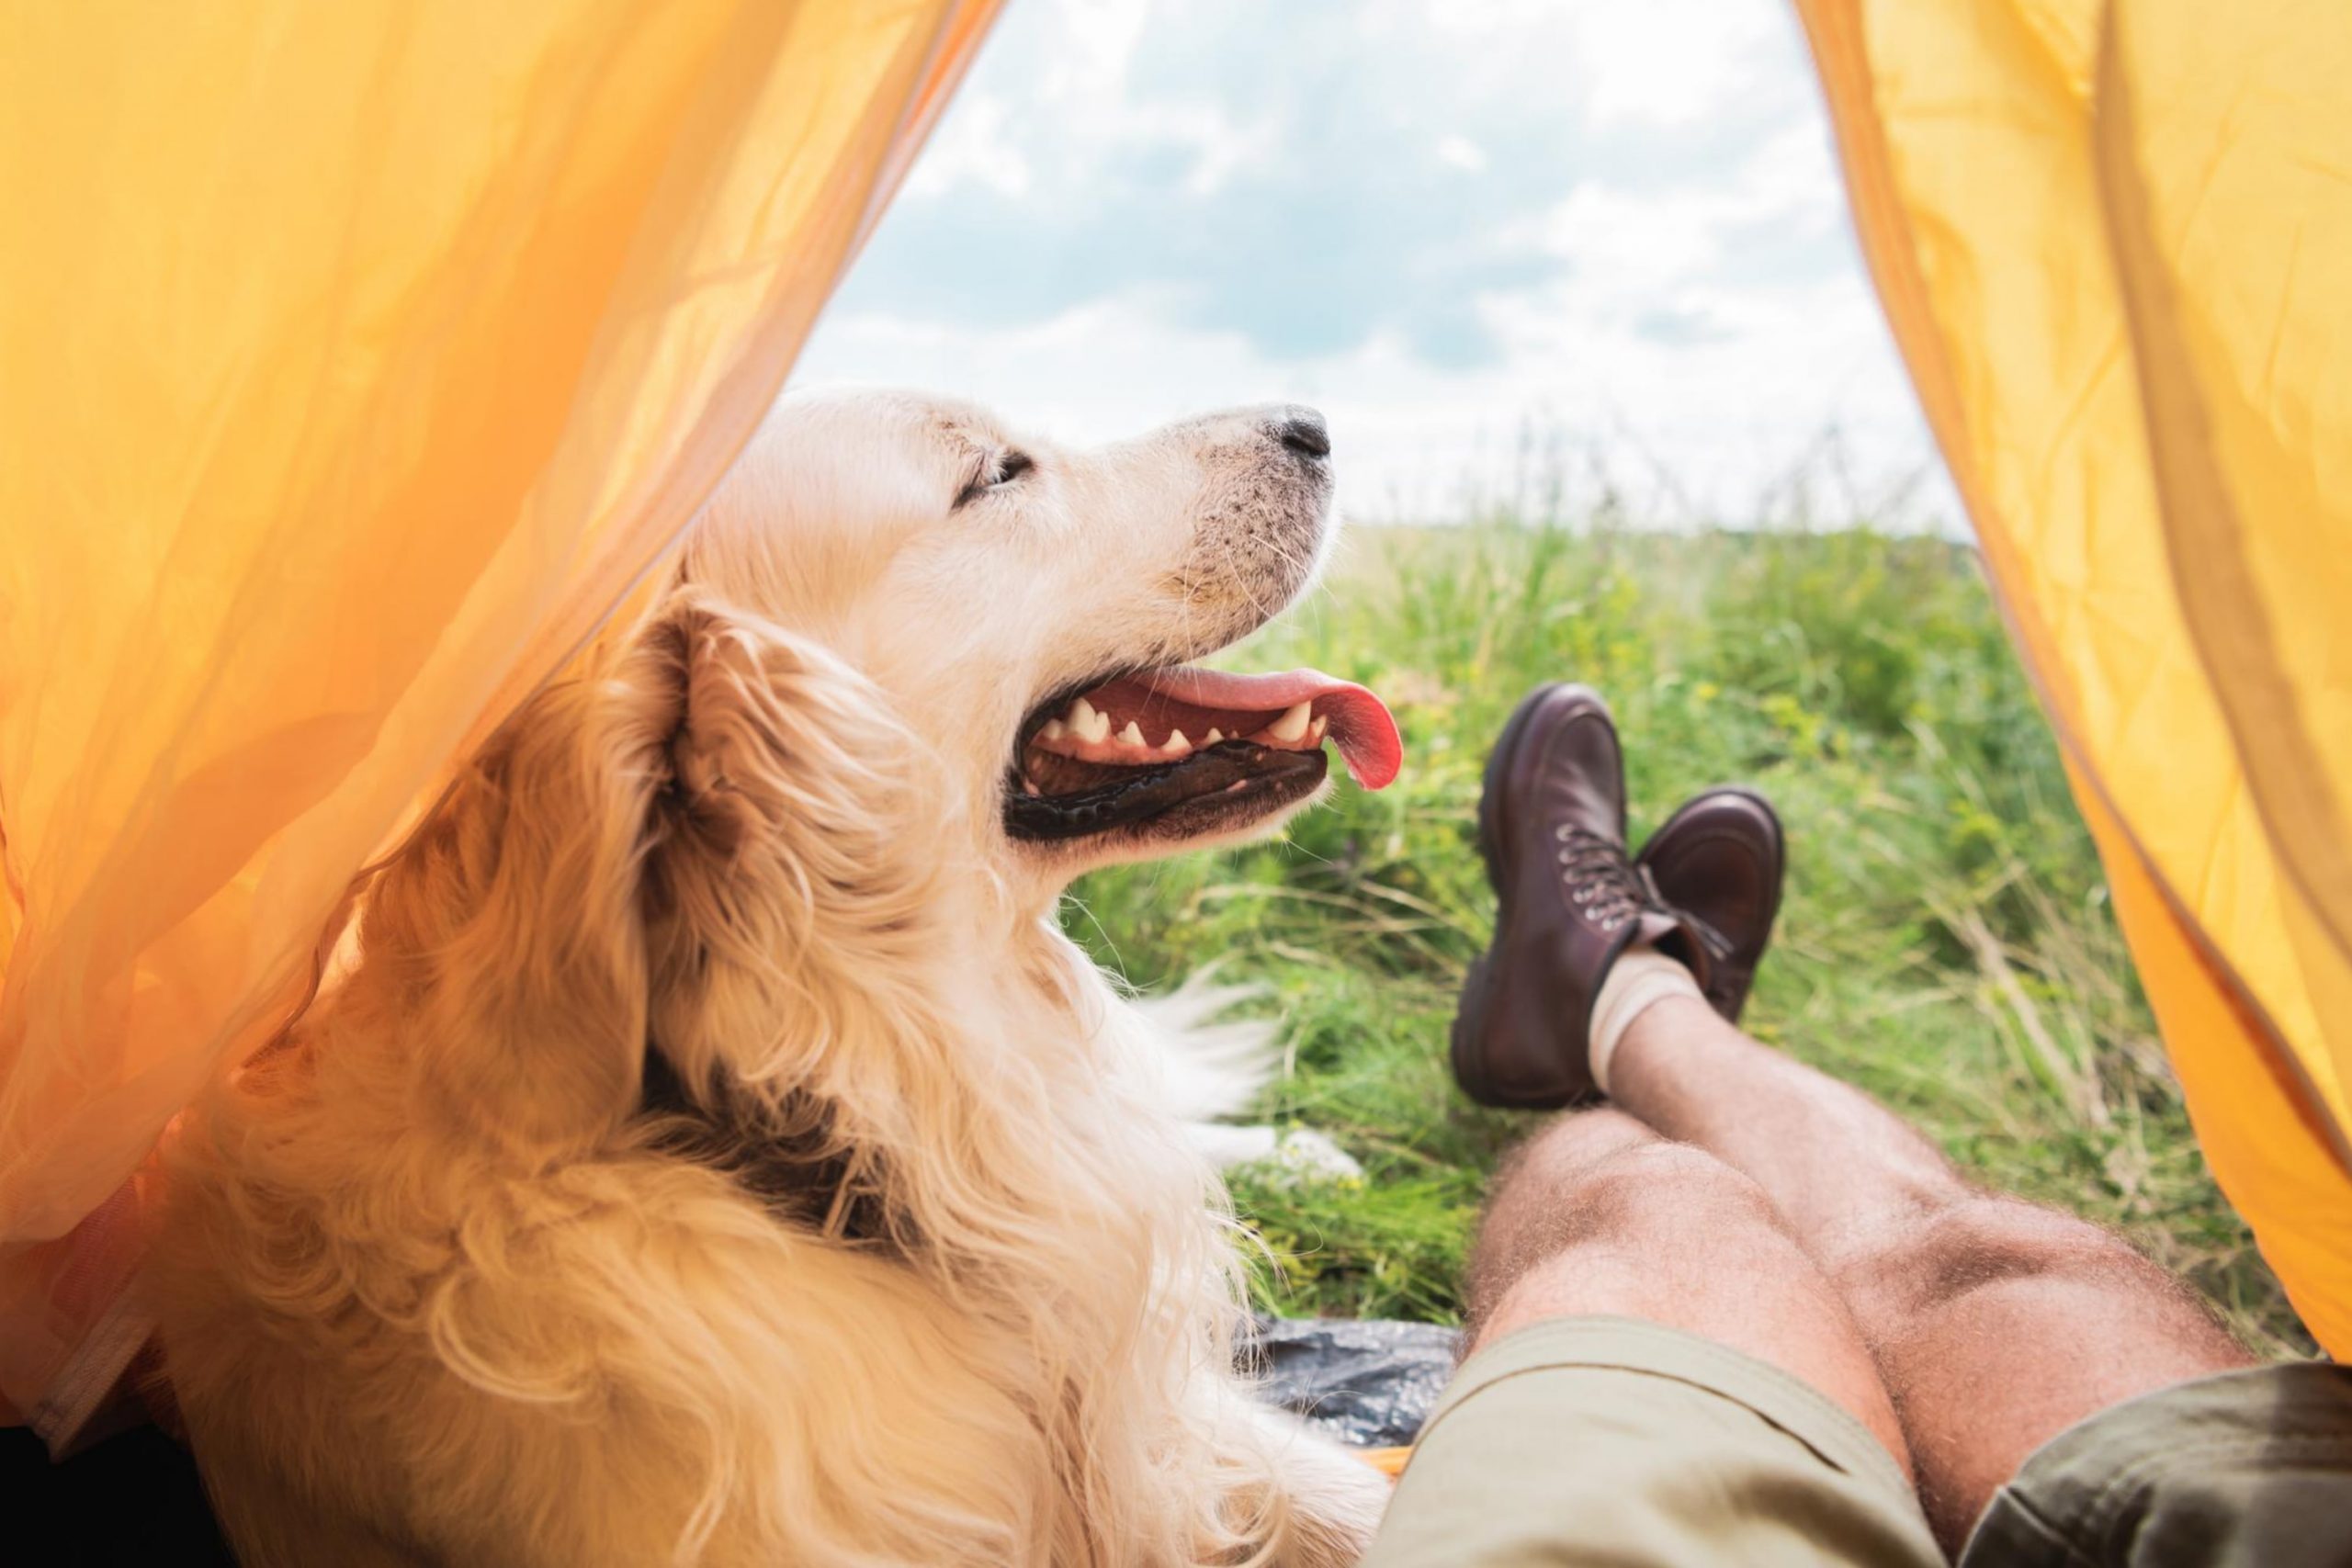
[{"x1": 1453, "y1": 684, "x2": 1708, "y2": 1110}]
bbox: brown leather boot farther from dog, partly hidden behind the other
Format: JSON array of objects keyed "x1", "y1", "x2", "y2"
[{"x1": 1634, "y1": 785, "x2": 1788, "y2": 1022}]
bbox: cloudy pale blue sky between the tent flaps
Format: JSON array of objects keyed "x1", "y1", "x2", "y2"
[{"x1": 795, "y1": 0, "x2": 1959, "y2": 526}]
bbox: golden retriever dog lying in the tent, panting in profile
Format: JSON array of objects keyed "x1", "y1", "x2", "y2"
[{"x1": 153, "y1": 392, "x2": 1397, "y2": 1568}]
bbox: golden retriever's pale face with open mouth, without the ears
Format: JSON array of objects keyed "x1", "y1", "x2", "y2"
[{"x1": 684, "y1": 395, "x2": 1399, "y2": 886}]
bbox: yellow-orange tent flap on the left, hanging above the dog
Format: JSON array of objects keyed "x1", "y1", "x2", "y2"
[{"x1": 0, "y1": 0, "x2": 995, "y2": 1425}]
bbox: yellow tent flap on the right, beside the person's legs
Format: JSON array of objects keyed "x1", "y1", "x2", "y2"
[{"x1": 1797, "y1": 0, "x2": 2352, "y2": 1357}]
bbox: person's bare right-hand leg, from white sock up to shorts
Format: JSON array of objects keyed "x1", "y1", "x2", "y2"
[{"x1": 1609, "y1": 997, "x2": 2251, "y2": 1550}]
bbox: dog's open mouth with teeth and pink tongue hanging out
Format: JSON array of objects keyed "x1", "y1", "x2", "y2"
[{"x1": 1004, "y1": 665, "x2": 1404, "y2": 840}]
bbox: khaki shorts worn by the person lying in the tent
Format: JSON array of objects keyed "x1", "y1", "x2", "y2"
[{"x1": 1364, "y1": 1316, "x2": 2352, "y2": 1568}]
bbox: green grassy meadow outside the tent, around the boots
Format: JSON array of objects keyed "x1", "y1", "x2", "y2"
[{"x1": 1066, "y1": 525, "x2": 2310, "y2": 1354}]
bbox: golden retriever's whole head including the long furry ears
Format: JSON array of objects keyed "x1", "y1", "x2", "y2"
[{"x1": 365, "y1": 395, "x2": 1399, "y2": 1145}]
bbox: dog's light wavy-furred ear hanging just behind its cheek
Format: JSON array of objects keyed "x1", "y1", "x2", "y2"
[{"x1": 644, "y1": 590, "x2": 938, "y2": 1110}]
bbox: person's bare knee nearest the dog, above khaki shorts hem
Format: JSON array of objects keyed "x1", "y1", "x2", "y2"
[{"x1": 1465, "y1": 1110, "x2": 1910, "y2": 1474}]
